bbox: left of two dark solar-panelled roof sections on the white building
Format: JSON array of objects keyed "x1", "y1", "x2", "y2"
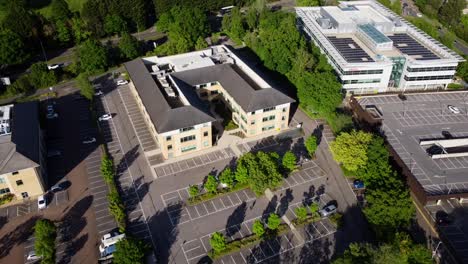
[{"x1": 327, "y1": 36, "x2": 374, "y2": 62}]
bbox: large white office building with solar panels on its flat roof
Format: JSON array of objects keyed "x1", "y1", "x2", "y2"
[{"x1": 296, "y1": 1, "x2": 463, "y2": 94}]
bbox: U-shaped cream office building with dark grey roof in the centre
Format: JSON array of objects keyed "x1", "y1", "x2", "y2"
[{"x1": 125, "y1": 45, "x2": 294, "y2": 159}]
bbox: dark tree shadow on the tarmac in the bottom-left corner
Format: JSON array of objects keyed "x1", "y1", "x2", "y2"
[{"x1": 0, "y1": 216, "x2": 39, "y2": 258}]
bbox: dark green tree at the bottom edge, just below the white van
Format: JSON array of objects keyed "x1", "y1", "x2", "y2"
[{"x1": 112, "y1": 237, "x2": 149, "y2": 264}]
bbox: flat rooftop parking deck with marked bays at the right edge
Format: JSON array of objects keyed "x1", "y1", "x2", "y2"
[{"x1": 356, "y1": 92, "x2": 468, "y2": 198}]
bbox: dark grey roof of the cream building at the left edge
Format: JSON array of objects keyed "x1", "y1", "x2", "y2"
[{"x1": 0, "y1": 102, "x2": 41, "y2": 174}]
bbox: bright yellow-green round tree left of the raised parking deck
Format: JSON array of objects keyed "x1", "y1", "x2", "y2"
[{"x1": 330, "y1": 130, "x2": 372, "y2": 172}]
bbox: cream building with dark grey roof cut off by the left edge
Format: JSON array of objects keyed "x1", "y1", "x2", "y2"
[{"x1": 0, "y1": 102, "x2": 46, "y2": 200}]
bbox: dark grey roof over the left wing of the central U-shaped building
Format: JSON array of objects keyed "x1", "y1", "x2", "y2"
[{"x1": 125, "y1": 59, "x2": 215, "y2": 133}]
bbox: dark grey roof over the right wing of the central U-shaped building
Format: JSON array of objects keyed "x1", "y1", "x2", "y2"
[{"x1": 171, "y1": 64, "x2": 294, "y2": 112}]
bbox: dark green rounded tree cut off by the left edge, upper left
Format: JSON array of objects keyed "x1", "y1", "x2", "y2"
[{"x1": 0, "y1": 29, "x2": 28, "y2": 65}]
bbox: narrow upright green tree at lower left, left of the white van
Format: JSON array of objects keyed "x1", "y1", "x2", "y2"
[{"x1": 34, "y1": 219, "x2": 57, "y2": 263}]
